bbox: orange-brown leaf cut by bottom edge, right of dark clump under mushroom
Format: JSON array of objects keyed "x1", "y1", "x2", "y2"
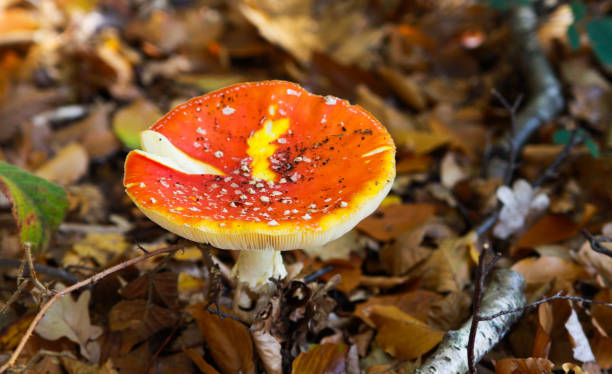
[{"x1": 291, "y1": 343, "x2": 348, "y2": 374}]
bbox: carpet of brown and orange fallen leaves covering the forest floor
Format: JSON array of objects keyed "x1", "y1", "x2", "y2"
[{"x1": 0, "y1": 0, "x2": 612, "y2": 374}]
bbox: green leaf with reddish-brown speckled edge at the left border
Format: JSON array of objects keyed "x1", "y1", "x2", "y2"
[{"x1": 0, "y1": 161, "x2": 68, "y2": 252}]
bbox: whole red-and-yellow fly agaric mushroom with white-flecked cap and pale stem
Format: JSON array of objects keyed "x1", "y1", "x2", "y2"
[{"x1": 124, "y1": 81, "x2": 395, "y2": 288}]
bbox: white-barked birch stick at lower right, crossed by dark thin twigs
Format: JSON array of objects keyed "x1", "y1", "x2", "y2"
[{"x1": 414, "y1": 269, "x2": 525, "y2": 374}]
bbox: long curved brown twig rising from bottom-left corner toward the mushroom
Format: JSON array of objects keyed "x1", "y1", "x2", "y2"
[{"x1": 0, "y1": 244, "x2": 185, "y2": 373}]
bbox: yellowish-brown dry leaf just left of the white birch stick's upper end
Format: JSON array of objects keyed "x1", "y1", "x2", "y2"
[{"x1": 416, "y1": 232, "x2": 476, "y2": 292}]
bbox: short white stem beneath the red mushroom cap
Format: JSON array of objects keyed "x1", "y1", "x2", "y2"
[{"x1": 232, "y1": 249, "x2": 287, "y2": 291}]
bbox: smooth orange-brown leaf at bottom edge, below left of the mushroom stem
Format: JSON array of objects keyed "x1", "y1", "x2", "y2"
[{"x1": 187, "y1": 303, "x2": 255, "y2": 374}]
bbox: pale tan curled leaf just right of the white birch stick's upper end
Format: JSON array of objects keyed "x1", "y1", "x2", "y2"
[{"x1": 511, "y1": 256, "x2": 586, "y2": 284}]
